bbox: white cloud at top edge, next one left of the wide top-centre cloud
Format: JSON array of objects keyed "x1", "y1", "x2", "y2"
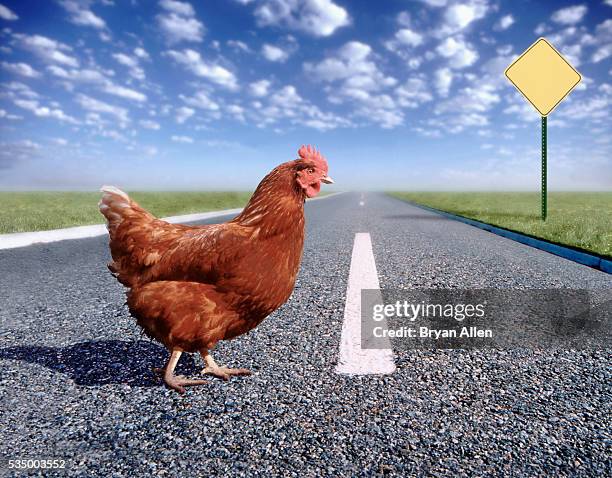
[{"x1": 156, "y1": 0, "x2": 204, "y2": 44}]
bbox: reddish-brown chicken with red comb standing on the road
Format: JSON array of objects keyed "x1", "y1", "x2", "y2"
[{"x1": 99, "y1": 146, "x2": 333, "y2": 393}]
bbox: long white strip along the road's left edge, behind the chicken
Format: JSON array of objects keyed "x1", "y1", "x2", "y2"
[{"x1": 0, "y1": 192, "x2": 342, "y2": 249}]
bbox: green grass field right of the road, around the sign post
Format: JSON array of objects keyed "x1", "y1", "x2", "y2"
[{"x1": 390, "y1": 192, "x2": 612, "y2": 258}]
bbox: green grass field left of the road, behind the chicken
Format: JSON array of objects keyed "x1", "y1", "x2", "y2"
[{"x1": 0, "y1": 191, "x2": 252, "y2": 234}]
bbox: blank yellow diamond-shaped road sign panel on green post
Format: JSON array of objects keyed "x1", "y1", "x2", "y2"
[{"x1": 506, "y1": 38, "x2": 582, "y2": 116}]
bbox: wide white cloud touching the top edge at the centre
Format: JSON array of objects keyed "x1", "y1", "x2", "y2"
[{"x1": 255, "y1": 0, "x2": 350, "y2": 37}]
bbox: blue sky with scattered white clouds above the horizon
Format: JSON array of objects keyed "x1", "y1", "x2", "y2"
[{"x1": 0, "y1": 0, "x2": 612, "y2": 190}]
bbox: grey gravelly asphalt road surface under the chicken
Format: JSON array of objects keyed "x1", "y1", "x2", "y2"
[{"x1": 0, "y1": 193, "x2": 612, "y2": 477}]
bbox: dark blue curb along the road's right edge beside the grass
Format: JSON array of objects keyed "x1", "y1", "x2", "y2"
[{"x1": 395, "y1": 198, "x2": 612, "y2": 274}]
